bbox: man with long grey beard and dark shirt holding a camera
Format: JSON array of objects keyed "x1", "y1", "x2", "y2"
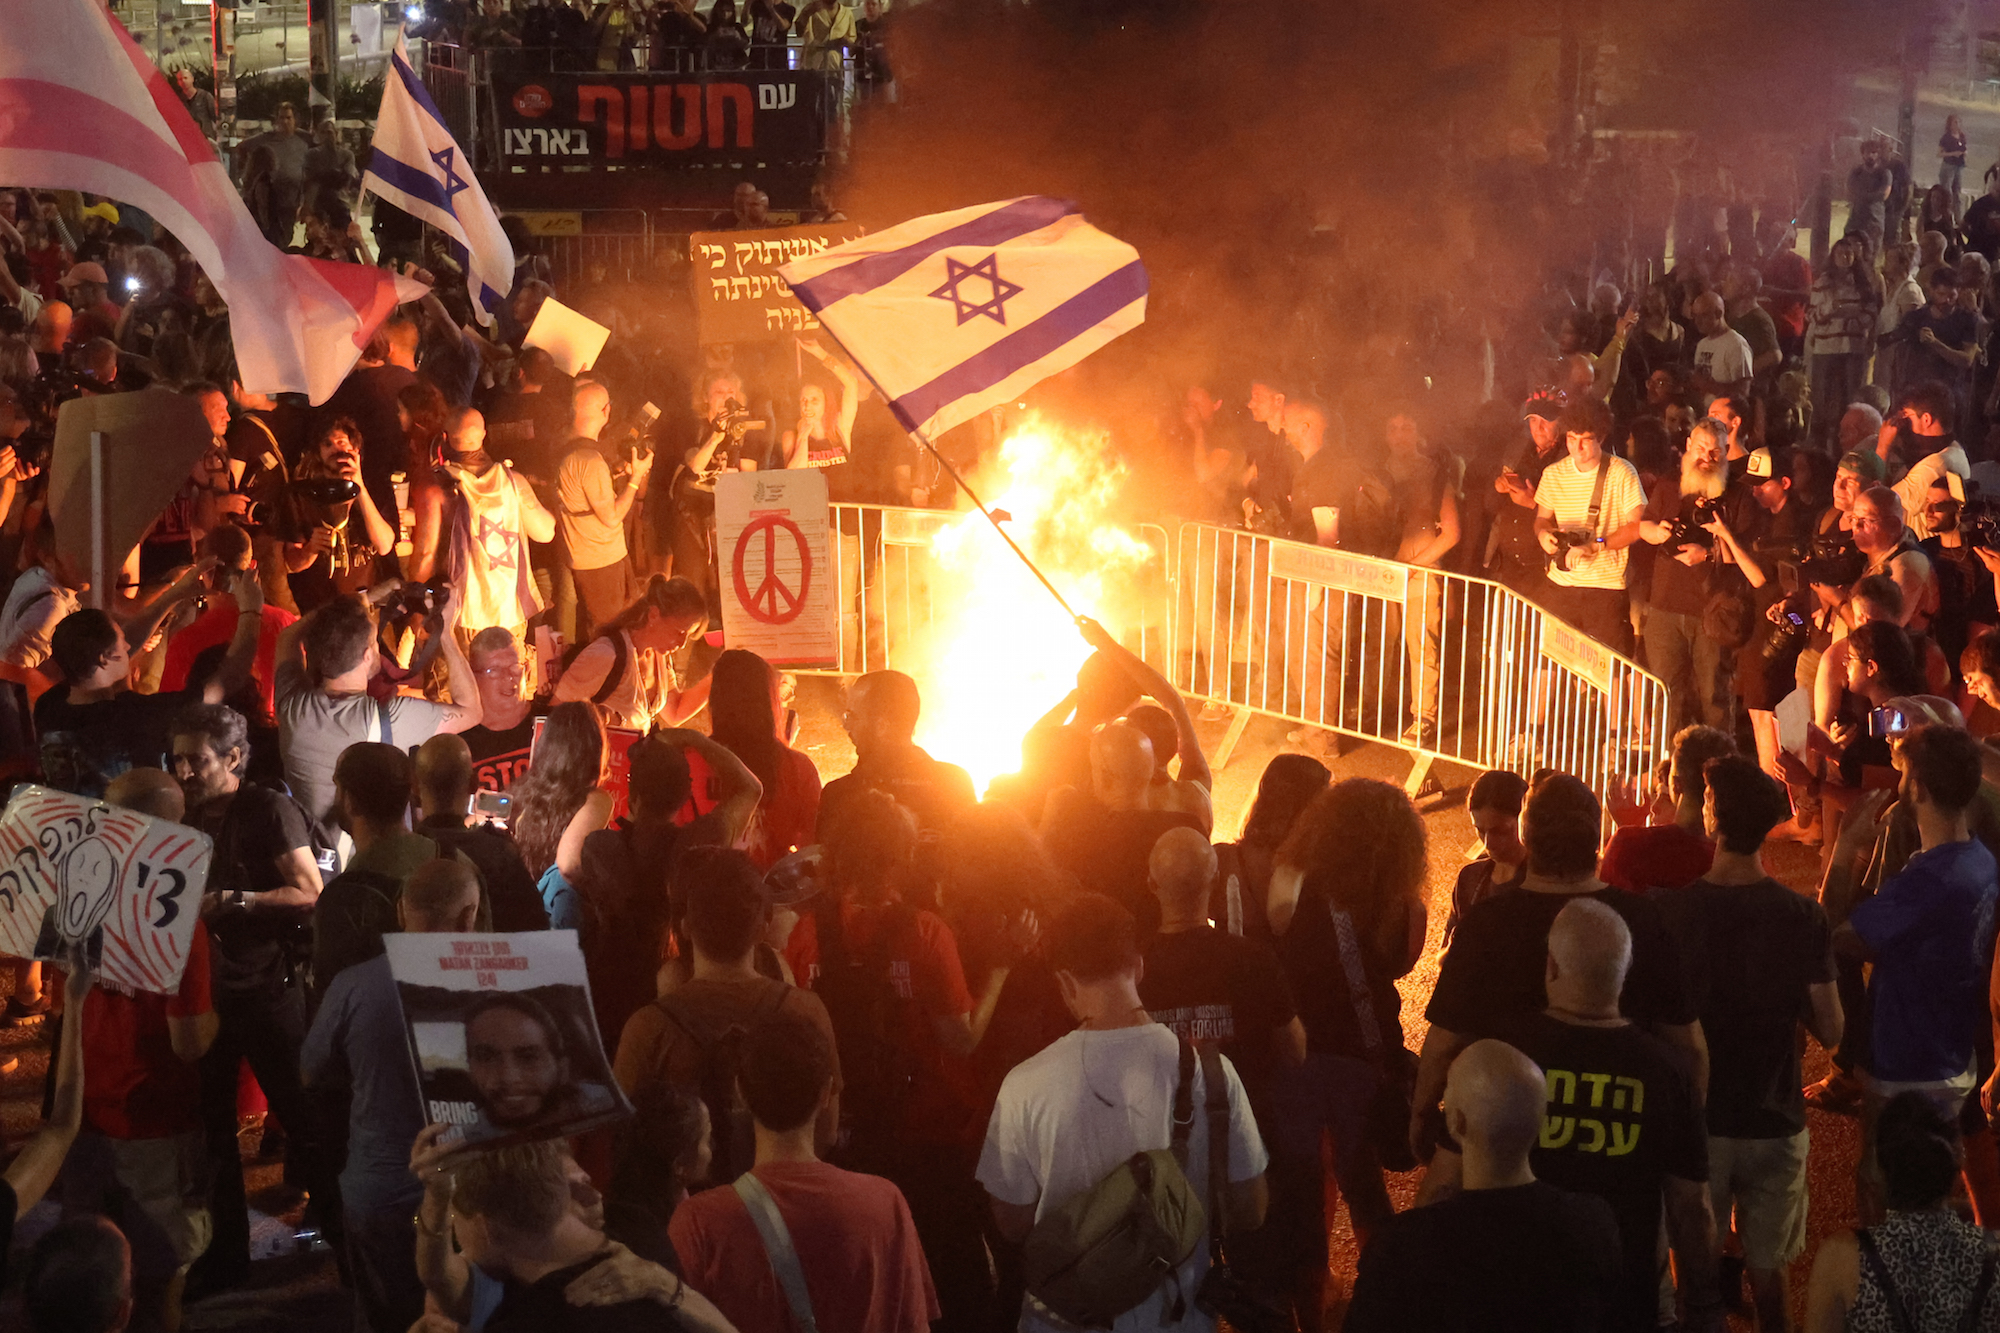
[{"x1": 1640, "y1": 416, "x2": 1750, "y2": 731}]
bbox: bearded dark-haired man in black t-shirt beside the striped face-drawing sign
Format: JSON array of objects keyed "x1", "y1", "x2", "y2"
[{"x1": 172, "y1": 705, "x2": 324, "y2": 1299}]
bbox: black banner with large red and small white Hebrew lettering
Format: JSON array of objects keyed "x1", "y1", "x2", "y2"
[{"x1": 492, "y1": 70, "x2": 832, "y2": 170}]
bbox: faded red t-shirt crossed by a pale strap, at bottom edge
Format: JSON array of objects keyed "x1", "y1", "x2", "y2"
[{"x1": 666, "y1": 1161, "x2": 938, "y2": 1333}]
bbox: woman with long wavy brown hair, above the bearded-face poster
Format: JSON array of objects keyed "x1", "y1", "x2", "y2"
[{"x1": 512, "y1": 688, "x2": 612, "y2": 931}]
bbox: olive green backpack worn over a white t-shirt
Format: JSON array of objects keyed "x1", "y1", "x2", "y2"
[{"x1": 1022, "y1": 1037, "x2": 1208, "y2": 1329}]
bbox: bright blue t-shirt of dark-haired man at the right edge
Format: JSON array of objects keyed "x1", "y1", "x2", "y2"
[{"x1": 1848, "y1": 839, "x2": 1996, "y2": 1083}]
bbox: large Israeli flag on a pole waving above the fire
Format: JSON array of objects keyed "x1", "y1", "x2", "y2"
[{"x1": 778, "y1": 196, "x2": 1146, "y2": 436}]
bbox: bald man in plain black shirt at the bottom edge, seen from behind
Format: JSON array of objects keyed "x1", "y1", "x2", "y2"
[{"x1": 1344, "y1": 1041, "x2": 1624, "y2": 1333}]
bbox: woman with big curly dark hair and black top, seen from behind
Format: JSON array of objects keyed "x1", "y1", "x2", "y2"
[{"x1": 1266, "y1": 779, "x2": 1426, "y2": 1329}]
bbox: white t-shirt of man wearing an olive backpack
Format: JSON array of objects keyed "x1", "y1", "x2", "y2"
[{"x1": 978, "y1": 1023, "x2": 1270, "y2": 1333}]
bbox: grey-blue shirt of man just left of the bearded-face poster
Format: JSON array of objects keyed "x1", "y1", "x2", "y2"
[{"x1": 298, "y1": 953, "x2": 424, "y2": 1213}]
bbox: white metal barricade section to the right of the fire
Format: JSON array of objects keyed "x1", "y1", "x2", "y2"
[{"x1": 1168, "y1": 522, "x2": 1668, "y2": 795}]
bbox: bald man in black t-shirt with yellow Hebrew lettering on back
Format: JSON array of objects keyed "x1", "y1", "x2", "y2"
[{"x1": 1424, "y1": 899, "x2": 1722, "y2": 1331}]
